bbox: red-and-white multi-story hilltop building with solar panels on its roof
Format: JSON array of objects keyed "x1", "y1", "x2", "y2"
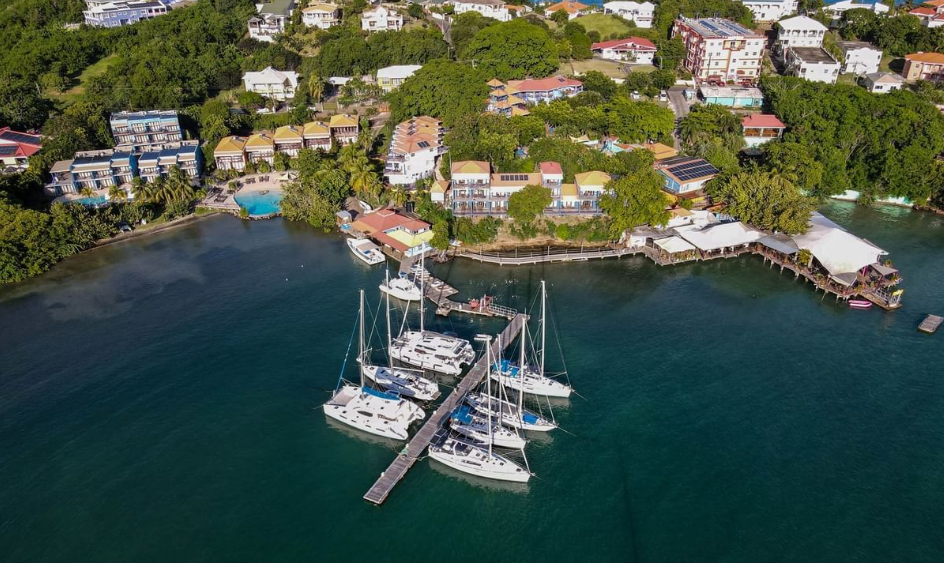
[{"x1": 672, "y1": 17, "x2": 766, "y2": 84}]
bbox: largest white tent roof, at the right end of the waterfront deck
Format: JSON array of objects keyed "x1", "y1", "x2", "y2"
[{"x1": 793, "y1": 212, "x2": 888, "y2": 276}]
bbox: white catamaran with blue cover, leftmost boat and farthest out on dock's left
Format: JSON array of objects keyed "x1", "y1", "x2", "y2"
[{"x1": 324, "y1": 290, "x2": 426, "y2": 440}]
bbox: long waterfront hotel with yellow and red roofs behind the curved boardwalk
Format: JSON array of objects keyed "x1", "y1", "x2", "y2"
[{"x1": 446, "y1": 161, "x2": 611, "y2": 217}]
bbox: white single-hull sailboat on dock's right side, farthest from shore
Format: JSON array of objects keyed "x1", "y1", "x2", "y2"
[{"x1": 429, "y1": 336, "x2": 531, "y2": 483}]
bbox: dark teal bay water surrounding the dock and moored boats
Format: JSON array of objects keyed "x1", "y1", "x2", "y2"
[{"x1": 0, "y1": 204, "x2": 944, "y2": 562}]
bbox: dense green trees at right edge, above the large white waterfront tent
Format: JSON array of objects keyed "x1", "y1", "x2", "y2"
[{"x1": 762, "y1": 77, "x2": 944, "y2": 201}]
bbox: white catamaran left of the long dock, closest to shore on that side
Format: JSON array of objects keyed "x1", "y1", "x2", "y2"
[{"x1": 389, "y1": 253, "x2": 475, "y2": 375}]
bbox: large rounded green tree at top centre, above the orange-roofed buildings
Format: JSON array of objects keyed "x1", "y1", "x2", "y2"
[{"x1": 463, "y1": 19, "x2": 559, "y2": 80}]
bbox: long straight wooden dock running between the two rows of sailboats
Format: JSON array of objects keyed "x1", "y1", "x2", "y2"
[{"x1": 364, "y1": 313, "x2": 527, "y2": 505}]
